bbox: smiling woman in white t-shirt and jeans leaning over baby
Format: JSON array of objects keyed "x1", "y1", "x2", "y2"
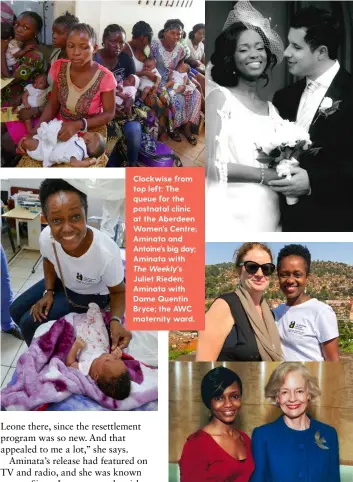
[{"x1": 11, "y1": 179, "x2": 131, "y2": 350}]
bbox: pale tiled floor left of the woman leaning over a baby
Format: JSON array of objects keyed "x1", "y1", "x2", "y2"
[{"x1": 1, "y1": 249, "x2": 43, "y2": 387}]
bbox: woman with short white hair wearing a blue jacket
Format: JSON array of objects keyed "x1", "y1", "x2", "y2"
[{"x1": 250, "y1": 362, "x2": 340, "y2": 482}]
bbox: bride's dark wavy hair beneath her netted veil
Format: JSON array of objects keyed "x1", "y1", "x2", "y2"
[{"x1": 211, "y1": 22, "x2": 277, "y2": 87}]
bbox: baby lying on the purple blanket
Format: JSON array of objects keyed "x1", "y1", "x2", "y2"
[{"x1": 66, "y1": 303, "x2": 131, "y2": 400}]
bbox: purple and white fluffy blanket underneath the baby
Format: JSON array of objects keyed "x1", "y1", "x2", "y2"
[{"x1": 1, "y1": 318, "x2": 158, "y2": 410}]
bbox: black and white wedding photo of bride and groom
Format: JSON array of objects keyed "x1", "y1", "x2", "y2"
[{"x1": 205, "y1": 0, "x2": 353, "y2": 235}]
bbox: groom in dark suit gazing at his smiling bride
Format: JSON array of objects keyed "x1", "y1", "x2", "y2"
[{"x1": 269, "y1": 6, "x2": 353, "y2": 232}]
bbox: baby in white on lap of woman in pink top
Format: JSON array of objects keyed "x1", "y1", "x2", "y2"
[{"x1": 17, "y1": 119, "x2": 105, "y2": 167}]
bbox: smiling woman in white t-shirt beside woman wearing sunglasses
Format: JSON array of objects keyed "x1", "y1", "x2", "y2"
[{"x1": 274, "y1": 244, "x2": 339, "y2": 361}]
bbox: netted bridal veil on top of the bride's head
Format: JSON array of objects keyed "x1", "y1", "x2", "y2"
[{"x1": 223, "y1": 0, "x2": 284, "y2": 64}]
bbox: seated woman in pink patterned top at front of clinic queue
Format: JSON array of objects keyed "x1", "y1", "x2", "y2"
[{"x1": 34, "y1": 23, "x2": 117, "y2": 141}]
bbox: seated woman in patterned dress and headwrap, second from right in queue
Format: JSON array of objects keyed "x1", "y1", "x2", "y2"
[{"x1": 151, "y1": 20, "x2": 201, "y2": 145}]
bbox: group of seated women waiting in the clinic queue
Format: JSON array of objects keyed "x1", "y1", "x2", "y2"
[{"x1": 1, "y1": 12, "x2": 205, "y2": 167}]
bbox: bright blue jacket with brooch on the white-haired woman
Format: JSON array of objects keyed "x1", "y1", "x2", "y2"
[{"x1": 250, "y1": 417, "x2": 340, "y2": 482}]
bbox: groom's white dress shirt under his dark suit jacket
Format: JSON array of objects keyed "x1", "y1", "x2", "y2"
[{"x1": 297, "y1": 60, "x2": 340, "y2": 128}]
